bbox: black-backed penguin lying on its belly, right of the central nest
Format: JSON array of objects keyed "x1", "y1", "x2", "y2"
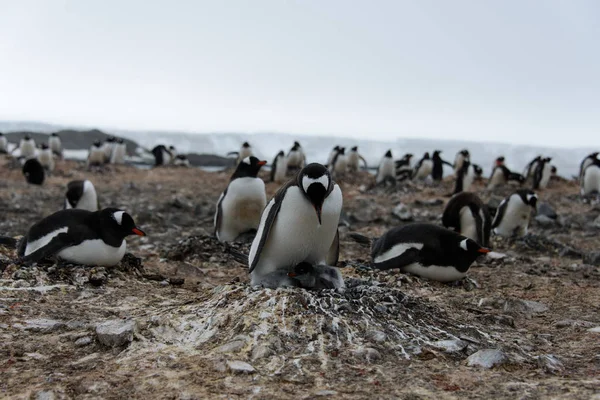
[{"x1": 364, "y1": 223, "x2": 489, "y2": 282}]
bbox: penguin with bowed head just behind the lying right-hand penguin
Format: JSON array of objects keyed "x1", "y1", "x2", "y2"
[{"x1": 442, "y1": 192, "x2": 492, "y2": 247}]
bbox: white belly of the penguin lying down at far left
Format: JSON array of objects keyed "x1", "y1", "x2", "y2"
[{"x1": 58, "y1": 239, "x2": 127, "y2": 265}]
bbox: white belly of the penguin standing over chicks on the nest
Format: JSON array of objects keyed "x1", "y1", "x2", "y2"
[{"x1": 249, "y1": 185, "x2": 343, "y2": 285}]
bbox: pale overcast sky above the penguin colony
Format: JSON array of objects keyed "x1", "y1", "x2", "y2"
[{"x1": 0, "y1": 0, "x2": 600, "y2": 146}]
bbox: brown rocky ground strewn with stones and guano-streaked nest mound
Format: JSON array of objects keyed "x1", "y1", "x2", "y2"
[{"x1": 0, "y1": 159, "x2": 600, "y2": 399}]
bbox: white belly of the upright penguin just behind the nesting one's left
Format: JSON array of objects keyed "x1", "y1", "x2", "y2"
[{"x1": 217, "y1": 178, "x2": 267, "y2": 242}]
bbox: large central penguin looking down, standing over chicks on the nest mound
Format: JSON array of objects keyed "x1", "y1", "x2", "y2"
[{"x1": 248, "y1": 163, "x2": 343, "y2": 287}]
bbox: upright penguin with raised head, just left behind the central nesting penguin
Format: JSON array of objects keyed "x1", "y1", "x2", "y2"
[{"x1": 214, "y1": 156, "x2": 267, "y2": 242}]
